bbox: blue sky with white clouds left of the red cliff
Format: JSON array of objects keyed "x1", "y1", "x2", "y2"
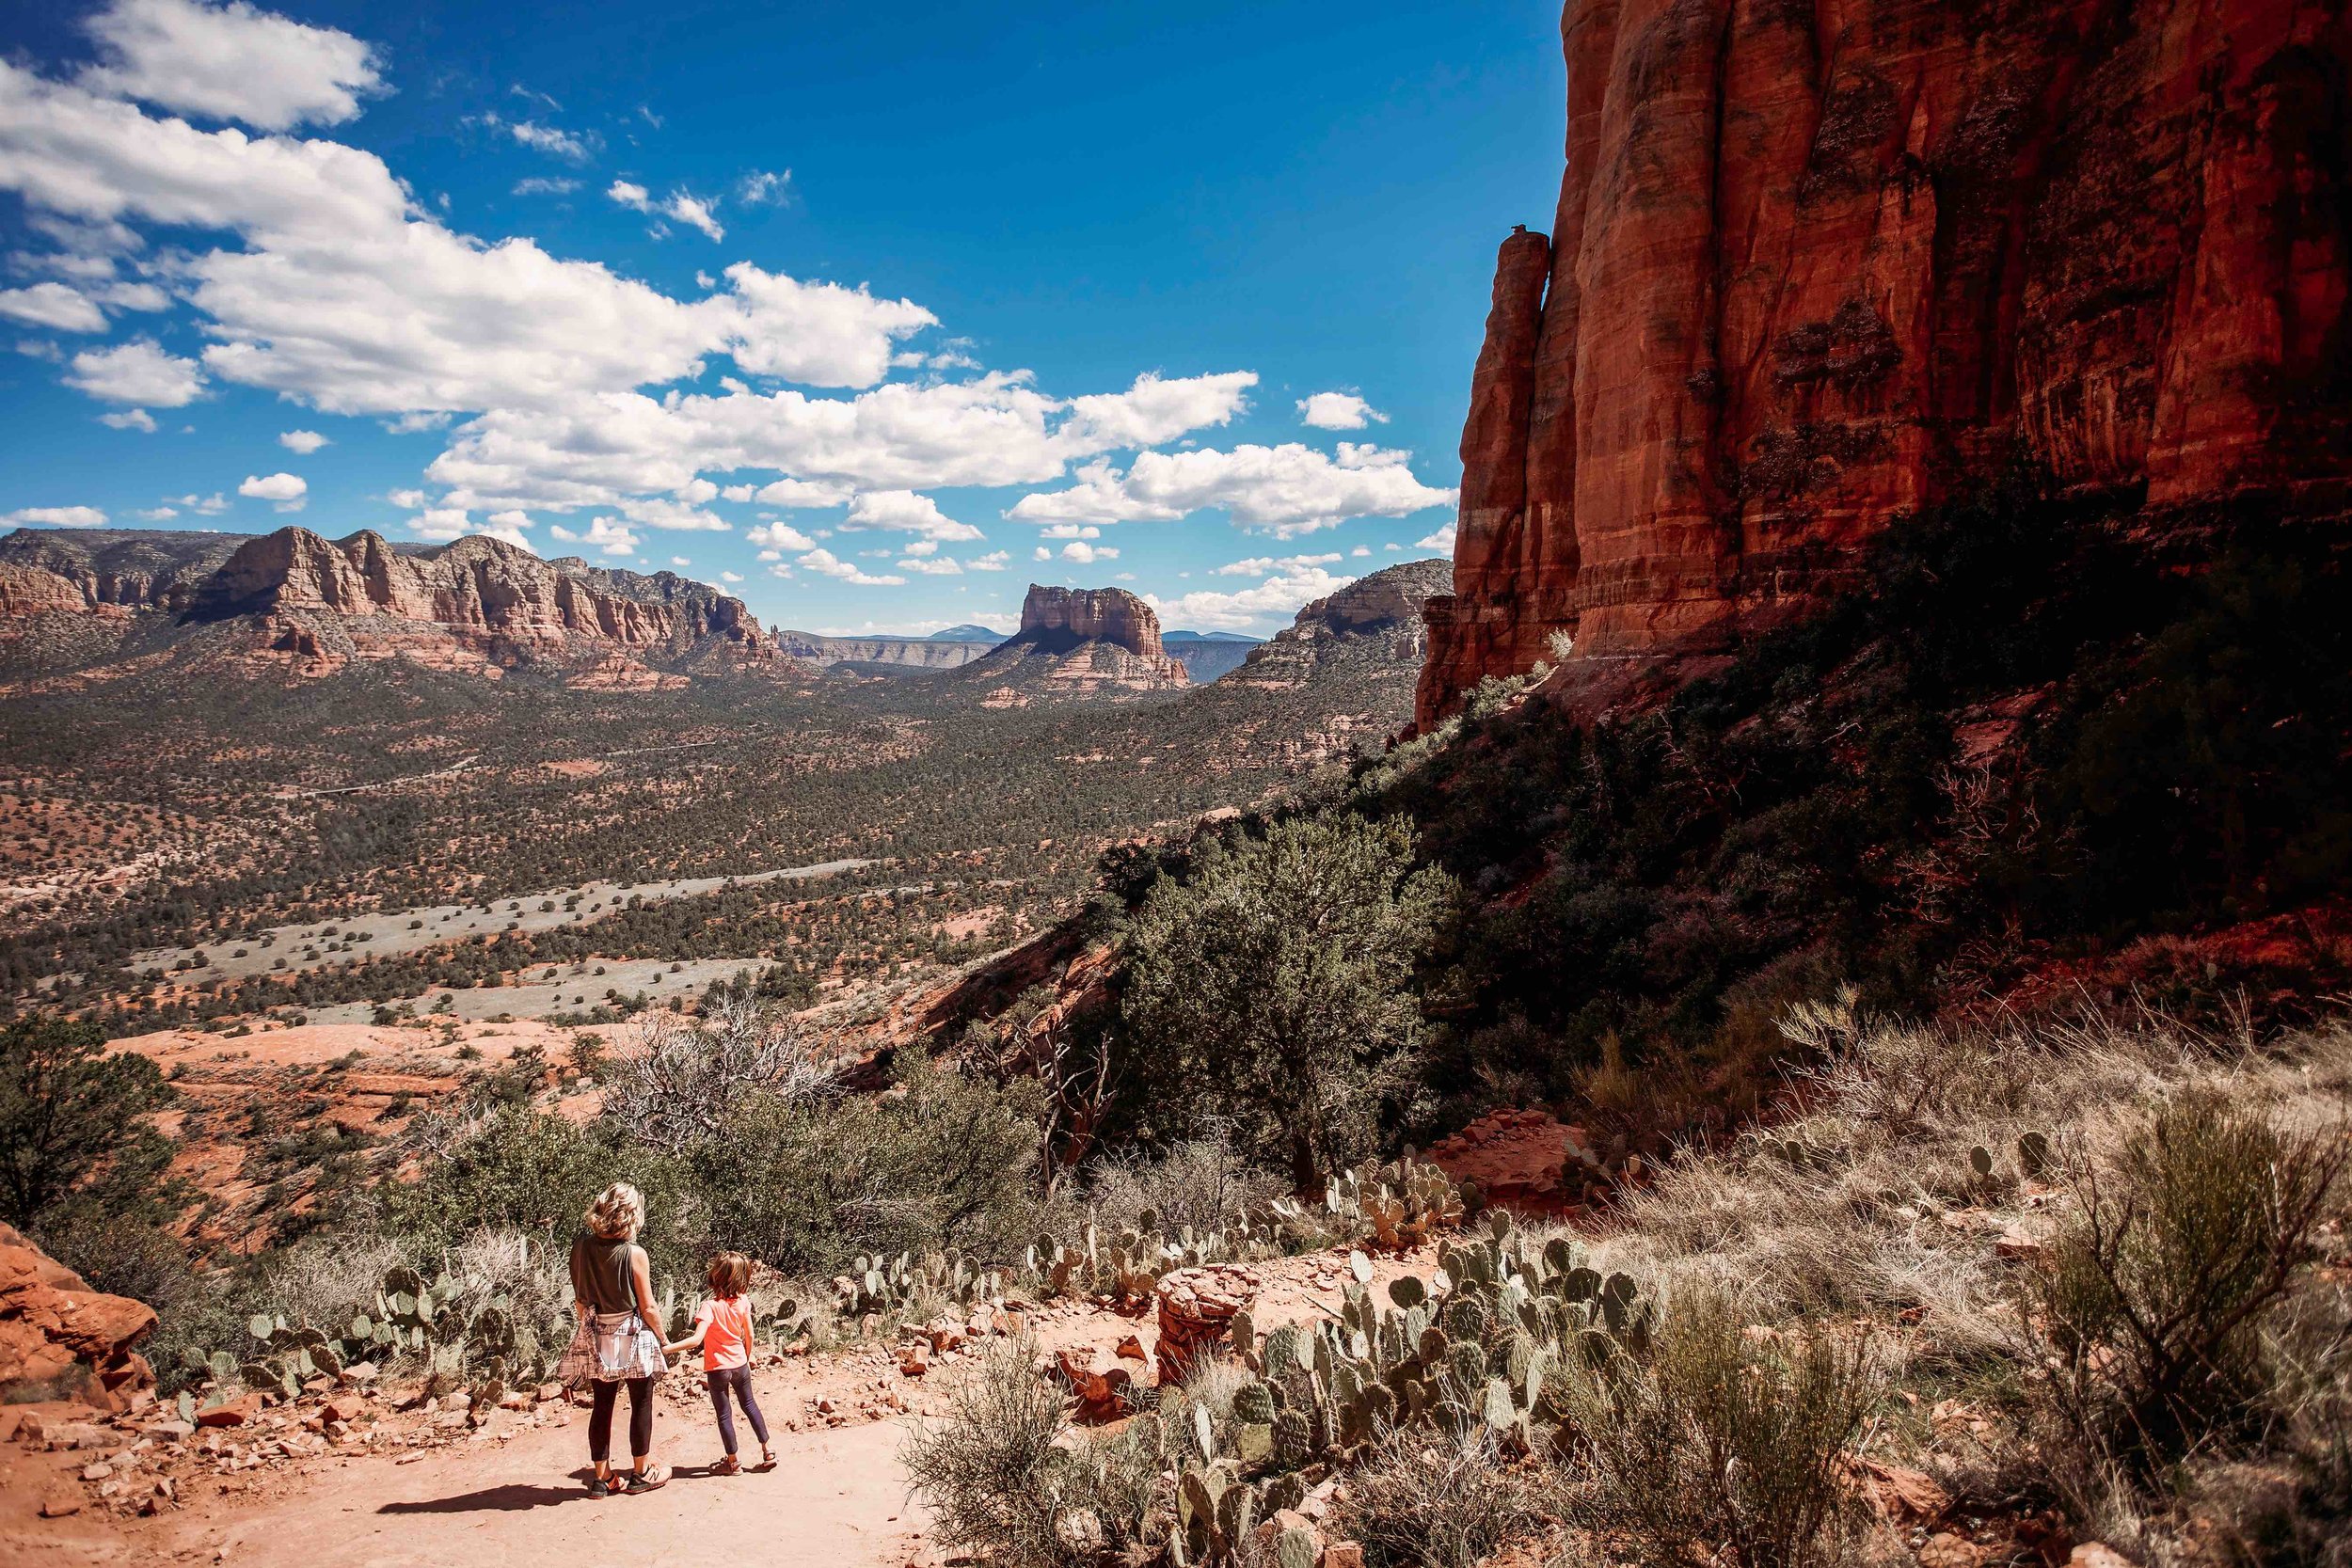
[{"x1": 0, "y1": 0, "x2": 1562, "y2": 632}]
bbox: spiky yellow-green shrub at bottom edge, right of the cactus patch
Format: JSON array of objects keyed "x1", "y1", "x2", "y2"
[{"x1": 1552, "y1": 1291, "x2": 1875, "y2": 1568}]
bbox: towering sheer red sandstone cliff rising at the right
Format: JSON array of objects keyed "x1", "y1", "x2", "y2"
[{"x1": 1419, "y1": 0, "x2": 2352, "y2": 724}]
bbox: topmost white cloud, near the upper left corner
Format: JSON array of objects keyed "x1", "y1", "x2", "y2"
[{"x1": 80, "y1": 0, "x2": 384, "y2": 132}]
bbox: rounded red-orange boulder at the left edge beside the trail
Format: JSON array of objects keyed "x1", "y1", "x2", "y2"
[{"x1": 0, "y1": 1225, "x2": 155, "y2": 1403}]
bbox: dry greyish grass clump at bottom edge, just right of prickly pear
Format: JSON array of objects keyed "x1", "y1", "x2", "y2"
[{"x1": 1341, "y1": 1425, "x2": 1552, "y2": 1568}]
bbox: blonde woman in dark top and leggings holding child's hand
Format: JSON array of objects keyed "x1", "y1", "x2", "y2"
[{"x1": 572, "y1": 1182, "x2": 671, "y2": 1497}]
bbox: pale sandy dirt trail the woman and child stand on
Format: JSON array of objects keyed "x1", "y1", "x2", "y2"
[{"x1": 13, "y1": 1248, "x2": 1435, "y2": 1568}]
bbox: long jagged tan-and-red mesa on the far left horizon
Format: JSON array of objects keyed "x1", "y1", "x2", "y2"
[{"x1": 0, "y1": 527, "x2": 786, "y2": 687}]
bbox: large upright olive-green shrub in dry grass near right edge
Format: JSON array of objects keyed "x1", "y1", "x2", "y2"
[{"x1": 2023, "y1": 1093, "x2": 2347, "y2": 1474}]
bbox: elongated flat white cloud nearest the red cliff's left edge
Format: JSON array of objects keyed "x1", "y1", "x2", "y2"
[{"x1": 1007, "y1": 442, "x2": 1456, "y2": 538}]
